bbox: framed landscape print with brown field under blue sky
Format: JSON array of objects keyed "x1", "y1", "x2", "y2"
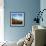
[{"x1": 10, "y1": 12, "x2": 25, "y2": 27}]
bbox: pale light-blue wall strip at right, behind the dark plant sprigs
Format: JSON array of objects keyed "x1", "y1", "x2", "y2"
[{"x1": 40, "y1": 0, "x2": 46, "y2": 27}]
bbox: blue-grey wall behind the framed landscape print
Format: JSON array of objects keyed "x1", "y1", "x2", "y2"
[{"x1": 4, "y1": 0, "x2": 40, "y2": 41}]
